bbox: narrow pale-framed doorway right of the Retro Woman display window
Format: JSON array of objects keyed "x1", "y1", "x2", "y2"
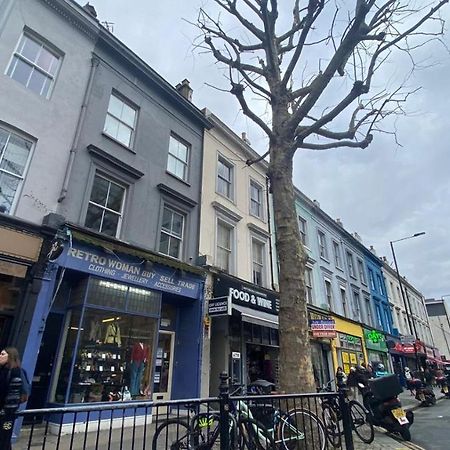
[{"x1": 153, "y1": 331, "x2": 175, "y2": 402}]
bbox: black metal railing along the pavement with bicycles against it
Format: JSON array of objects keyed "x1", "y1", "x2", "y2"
[{"x1": 13, "y1": 378, "x2": 353, "y2": 450}]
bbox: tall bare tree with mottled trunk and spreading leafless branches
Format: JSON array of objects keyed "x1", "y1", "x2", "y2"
[{"x1": 196, "y1": 0, "x2": 448, "y2": 392}]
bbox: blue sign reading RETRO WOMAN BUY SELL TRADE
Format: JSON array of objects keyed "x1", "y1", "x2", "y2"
[{"x1": 58, "y1": 242, "x2": 201, "y2": 298}]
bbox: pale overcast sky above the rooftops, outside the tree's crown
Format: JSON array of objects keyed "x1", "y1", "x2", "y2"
[{"x1": 80, "y1": 0, "x2": 450, "y2": 298}]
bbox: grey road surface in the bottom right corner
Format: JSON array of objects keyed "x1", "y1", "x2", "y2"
[{"x1": 411, "y1": 398, "x2": 450, "y2": 450}]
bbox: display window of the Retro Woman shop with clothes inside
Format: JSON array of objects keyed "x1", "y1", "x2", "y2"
[{"x1": 51, "y1": 279, "x2": 160, "y2": 403}]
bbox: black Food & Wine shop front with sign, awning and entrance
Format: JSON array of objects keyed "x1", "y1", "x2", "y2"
[{"x1": 208, "y1": 273, "x2": 279, "y2": 395}]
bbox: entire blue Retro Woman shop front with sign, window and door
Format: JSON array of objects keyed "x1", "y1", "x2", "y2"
[{"x1": 31, "y1": 240, "x2": 203, "y2": 418}]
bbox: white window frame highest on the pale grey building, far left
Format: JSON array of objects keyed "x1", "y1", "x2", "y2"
[{"x1": 5, "y1": 31, "x2": 63, "y2": 99}]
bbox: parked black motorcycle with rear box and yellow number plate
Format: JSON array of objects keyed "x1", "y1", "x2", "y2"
[{"x1": 358, "y1": 375, "x2": 414, "y2": 441}]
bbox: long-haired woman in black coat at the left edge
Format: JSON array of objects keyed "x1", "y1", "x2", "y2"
[{"x1": 0, "y1": 347, "x2": 22, "y2": 450}]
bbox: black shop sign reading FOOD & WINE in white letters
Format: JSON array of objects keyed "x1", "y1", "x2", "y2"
[{"x1": 214, "y1": 275, "x2": 279, "y2": 314}]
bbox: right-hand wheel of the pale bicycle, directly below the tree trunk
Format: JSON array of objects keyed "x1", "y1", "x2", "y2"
[{"x1": 276, "y1": 409, "x2": 327, "y2": 450}]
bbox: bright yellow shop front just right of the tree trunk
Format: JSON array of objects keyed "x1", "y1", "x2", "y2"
[{"x1": 332, "y1": 317, "x2": 367, "y2": 374}]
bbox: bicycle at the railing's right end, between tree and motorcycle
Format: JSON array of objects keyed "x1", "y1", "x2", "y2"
[{"x1": 321, "y1": 381, "x2": 375, "y2": 447}]
